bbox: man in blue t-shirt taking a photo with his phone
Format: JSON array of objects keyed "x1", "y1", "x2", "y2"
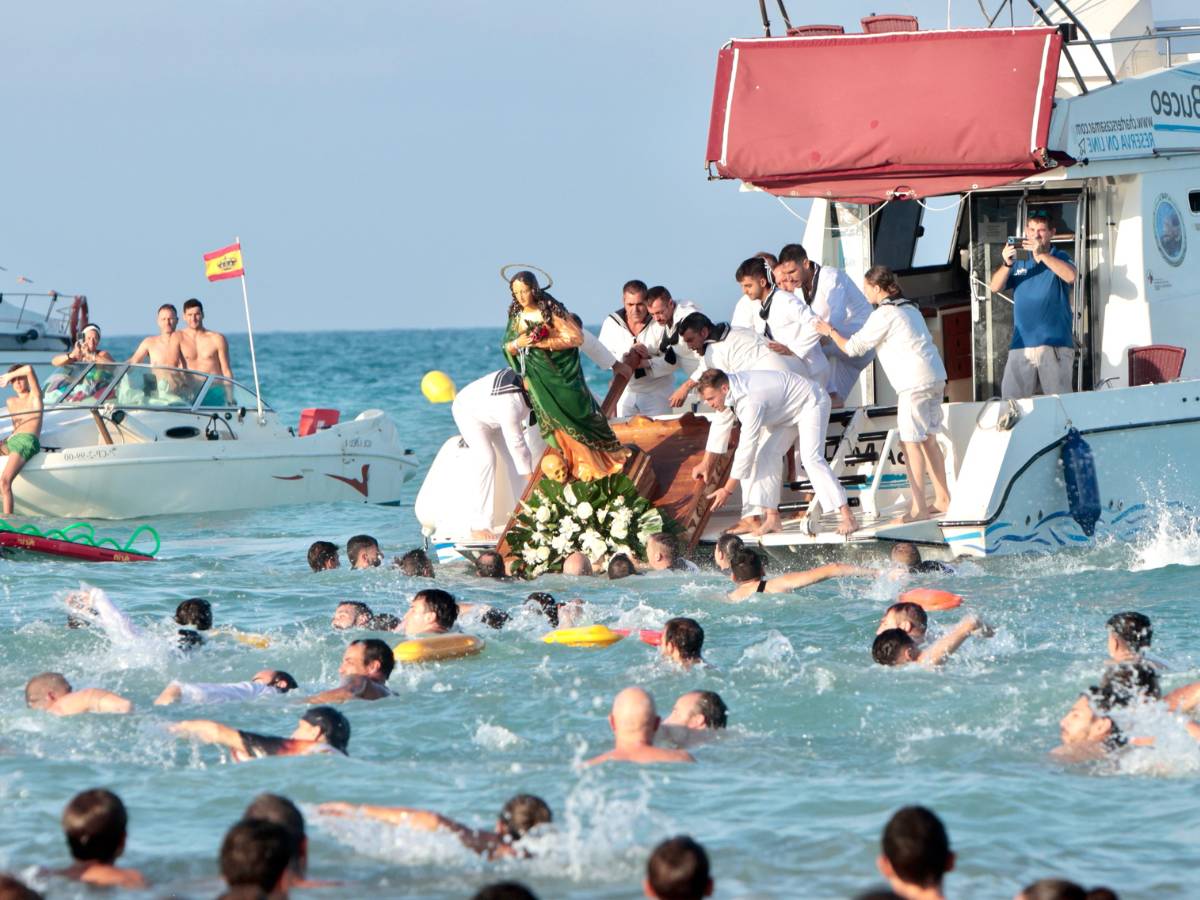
[{"x1": 991, "y1": 212, "x2": 1075, "y2": 400}]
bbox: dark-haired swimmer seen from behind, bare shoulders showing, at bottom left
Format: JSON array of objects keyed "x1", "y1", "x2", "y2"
[{"x1": 54, "y1": 788, "x2": 146, "y2": 890}]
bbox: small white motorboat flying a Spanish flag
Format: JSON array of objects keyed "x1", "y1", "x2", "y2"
[{"x1": 13, "y1": 362, "x2": 418, "y2": 518}]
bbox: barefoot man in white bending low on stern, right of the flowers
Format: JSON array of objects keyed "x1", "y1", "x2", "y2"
[{"x1": 694, "y1": 368, "x2": 857, "y2": 534}]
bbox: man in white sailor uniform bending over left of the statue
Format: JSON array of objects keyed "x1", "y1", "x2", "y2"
[{"x1": 450, "y1": 368, "x2": 544, "y2": 540}]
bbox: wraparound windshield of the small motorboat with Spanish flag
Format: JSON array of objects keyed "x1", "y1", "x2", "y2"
[{"x1": 42, "y1": 362, "x2": 266, "y2": 409}]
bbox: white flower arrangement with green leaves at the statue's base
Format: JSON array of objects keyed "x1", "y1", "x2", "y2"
[{"x1": 509, "y1": 475, "x2": 665, "y2": 577}]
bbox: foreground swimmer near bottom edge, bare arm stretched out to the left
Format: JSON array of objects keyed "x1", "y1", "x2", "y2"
[{"x1": 317, "y1": 793, "x2": 552, "y2": 859}]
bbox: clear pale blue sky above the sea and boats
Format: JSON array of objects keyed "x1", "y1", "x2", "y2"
[{"x1": 7, "y1": 0, "x2": 1188, "y2": 334}]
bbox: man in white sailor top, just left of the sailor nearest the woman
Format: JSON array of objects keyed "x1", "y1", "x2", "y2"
[{"x1": 734, "y1": 257, "x2": 829, "y2": 388}]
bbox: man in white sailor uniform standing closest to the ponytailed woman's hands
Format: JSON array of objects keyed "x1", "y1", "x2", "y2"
[{"x1": 775, "y1": 244, "x2": 875, "y2": 406}]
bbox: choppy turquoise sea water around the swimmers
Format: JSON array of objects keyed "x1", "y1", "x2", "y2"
[{"x1": 0, "y1": 329, "x2": 1200, "y2": 898}]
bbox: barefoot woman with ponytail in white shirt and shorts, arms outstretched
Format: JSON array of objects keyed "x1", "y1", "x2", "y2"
[{"x1": 817, "y1": 265, "x2": 950, "y2": 522}]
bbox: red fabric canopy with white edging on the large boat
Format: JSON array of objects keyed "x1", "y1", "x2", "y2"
[{"x1": 707, "y1": 28, "x2": 1062, "y2": 202}]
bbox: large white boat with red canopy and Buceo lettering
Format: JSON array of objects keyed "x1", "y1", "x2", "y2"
[{"x1": 422, "y1": 0, "x2": 1200, "y2": 557}]
